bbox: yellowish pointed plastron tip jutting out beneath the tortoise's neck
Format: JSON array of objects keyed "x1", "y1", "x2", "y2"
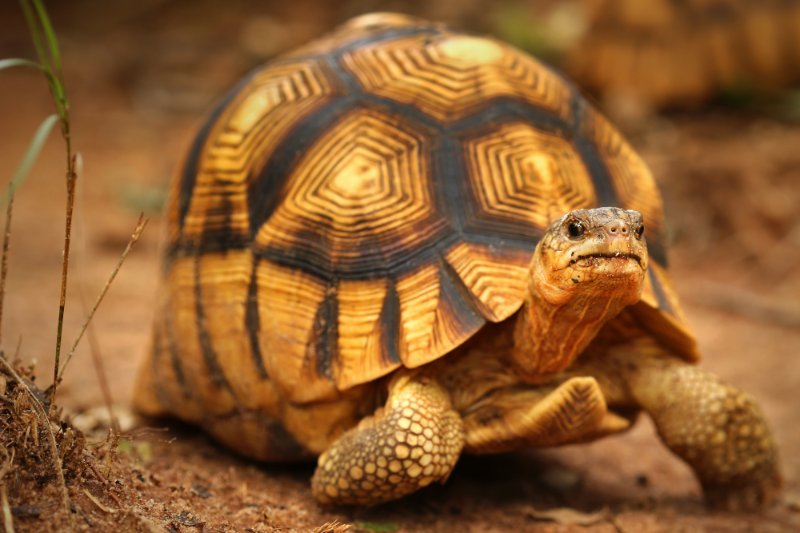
[{"x1": 463, "y1": 377, "x2": 630, "y2": 453}]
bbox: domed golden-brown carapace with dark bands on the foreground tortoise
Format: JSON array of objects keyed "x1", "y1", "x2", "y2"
[{"x1": 144, "y1": 15, "x2": 694, "y2": 410}]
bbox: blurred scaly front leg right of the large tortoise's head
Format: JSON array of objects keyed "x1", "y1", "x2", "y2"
[{"x1": 607, "y1": 341, "x2": 781, "y2": 510}]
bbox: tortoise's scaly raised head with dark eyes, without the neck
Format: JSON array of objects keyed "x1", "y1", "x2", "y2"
[{"x1": 531, "y1": 207, "x2": 647, "y2": 306}]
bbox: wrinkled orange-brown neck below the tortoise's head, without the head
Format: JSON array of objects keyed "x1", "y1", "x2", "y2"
[{"x1": 511, "y1": 272, "x2": 631, "y2": 382}]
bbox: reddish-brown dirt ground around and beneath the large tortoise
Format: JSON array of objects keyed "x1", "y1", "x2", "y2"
[{"x1": 0, "y1": 0, "x2": 800, "y2": 531}]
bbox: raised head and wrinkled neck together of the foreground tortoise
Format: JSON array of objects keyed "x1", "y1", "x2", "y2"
[{"x1": 514, "y1": 207, "x2": 647, "y2": 380}]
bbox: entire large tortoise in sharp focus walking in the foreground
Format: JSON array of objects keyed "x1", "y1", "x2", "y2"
[{"x1": 135, "y1": 14, "x2": 780, "y2": 508}]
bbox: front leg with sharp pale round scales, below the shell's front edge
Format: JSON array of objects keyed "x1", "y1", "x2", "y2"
[{"x1": 311, "y1": 374, "x2": 464, "y2": 505}]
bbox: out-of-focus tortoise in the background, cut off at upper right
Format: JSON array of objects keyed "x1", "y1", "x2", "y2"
[{"x1": 565, "y1": 0, "x2": 800, "y2": 108}]
